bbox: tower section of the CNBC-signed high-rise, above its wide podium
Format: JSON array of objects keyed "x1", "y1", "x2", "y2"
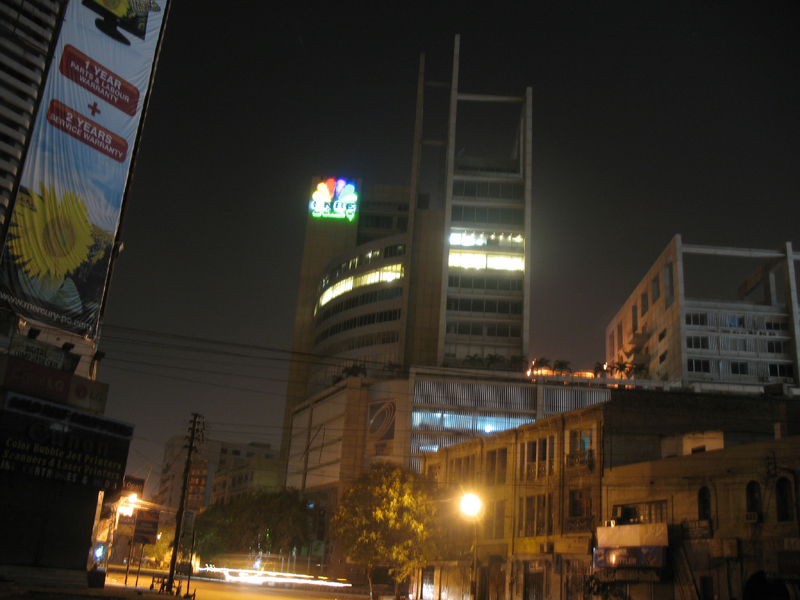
[{"x1": 284, "y1": 38, "x2": 532, "y2": 452}]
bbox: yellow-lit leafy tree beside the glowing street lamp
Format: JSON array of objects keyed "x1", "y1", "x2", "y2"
[{"x1": 331, "y1": 461, "x2": 436, "y2": 598}]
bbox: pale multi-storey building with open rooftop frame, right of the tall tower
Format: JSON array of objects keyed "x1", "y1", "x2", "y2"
[{"x1": 606, "y1": 235, "x2": 800, "y2": 395}]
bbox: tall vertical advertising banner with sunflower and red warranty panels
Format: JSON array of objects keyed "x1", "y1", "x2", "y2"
[{"x1": 0, "y1": 0, "x2": 168, "y2": 337}]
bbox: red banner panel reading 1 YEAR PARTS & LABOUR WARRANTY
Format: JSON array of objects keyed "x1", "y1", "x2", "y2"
[{"x1": 59, "y1": 44, "x2": 139, "y2": 116}]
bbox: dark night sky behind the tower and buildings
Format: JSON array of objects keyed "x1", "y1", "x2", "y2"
[{"x1": 99, "y1": 0, "x2": 800, "y2": 488}]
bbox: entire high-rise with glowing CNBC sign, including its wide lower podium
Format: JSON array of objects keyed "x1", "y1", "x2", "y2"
[{"x1": 282, "y1": 37, "x2": 576, "y2": 576}]
